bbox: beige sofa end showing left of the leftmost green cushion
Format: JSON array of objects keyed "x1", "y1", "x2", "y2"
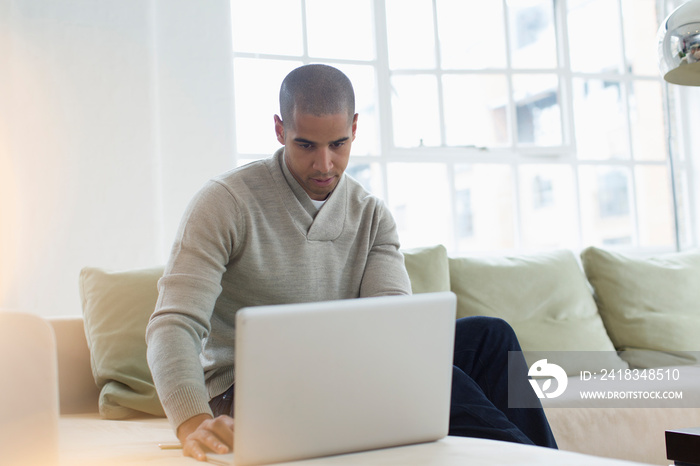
[{"x1": 47, "y1": 317, "x2": 100, "y2": 414}]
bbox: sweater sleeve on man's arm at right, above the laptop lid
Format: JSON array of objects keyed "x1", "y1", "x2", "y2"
[{"x1": 360, "y1": 202, "x2": 411, "y2": 297}]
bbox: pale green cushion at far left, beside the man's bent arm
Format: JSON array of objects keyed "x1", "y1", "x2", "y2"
[{"x1": 80, "y1": 267, "x2": 164, "y2": 419}]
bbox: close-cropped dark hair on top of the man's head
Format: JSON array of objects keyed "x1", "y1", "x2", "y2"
[{"x1": 280, "y1": 65, "x2": 355, "y2": 127}]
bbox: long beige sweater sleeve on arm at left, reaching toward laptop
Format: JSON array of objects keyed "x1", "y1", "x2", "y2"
[{"x1": 146, "y1": 181, "x2": 245, "y2": 429}]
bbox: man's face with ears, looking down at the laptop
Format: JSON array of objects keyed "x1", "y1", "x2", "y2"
[{"x1": 275, "y1": 111, "x2": 357, "y2": 201}]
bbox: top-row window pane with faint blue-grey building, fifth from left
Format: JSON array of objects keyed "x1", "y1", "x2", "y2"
[{"x1": 508, "y1": 0, "x2": 557, "y2": 68}]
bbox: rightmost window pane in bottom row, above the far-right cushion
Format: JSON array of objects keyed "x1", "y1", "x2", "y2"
[{"x1": 634, "y1": 166, "x2": 675, "y2": 246}]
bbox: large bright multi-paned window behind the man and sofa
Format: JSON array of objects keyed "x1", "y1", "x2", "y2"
[{"x1": 231, "y1": 0, "x2": 692, "y2": 253}]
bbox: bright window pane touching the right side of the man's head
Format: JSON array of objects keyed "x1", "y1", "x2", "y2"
[{"x1": 333, "y1": 64, "x2": 380, "y2": 155}]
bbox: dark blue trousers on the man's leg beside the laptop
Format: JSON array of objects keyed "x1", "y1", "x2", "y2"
[{"x1": 449, "y1": 317, "x2": 557, "y2": 448}]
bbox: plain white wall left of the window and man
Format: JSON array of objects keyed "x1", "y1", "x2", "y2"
[{"x1": 0, "y1": 0, "x2": 233, "y2": 315}]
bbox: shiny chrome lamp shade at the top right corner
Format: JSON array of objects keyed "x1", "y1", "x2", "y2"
[{"x1": 657, "y1": 0, "x2": 700, "y2": 86}]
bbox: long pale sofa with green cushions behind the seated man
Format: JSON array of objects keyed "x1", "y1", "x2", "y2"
[{"x1": 5, "y1": 245, "x2": 700, "y2": 465}]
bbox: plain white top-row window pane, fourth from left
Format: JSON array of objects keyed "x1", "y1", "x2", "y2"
[{"x1": 437, "y1": 0, "x2": 506, "y2": 69}]
